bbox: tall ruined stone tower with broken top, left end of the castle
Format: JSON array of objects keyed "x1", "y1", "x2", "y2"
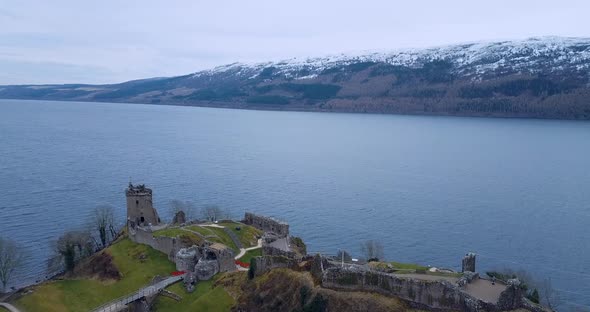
[{"x1": 125, "y1": 182, "x2": 160, "y2": 226}]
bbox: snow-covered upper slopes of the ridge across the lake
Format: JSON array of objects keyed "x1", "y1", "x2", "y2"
[{"x1": 194, "y1": 37, "x2": 590, "y2": 78}]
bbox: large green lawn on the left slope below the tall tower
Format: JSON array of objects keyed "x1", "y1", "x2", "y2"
[{"x1": 14, "y1": 239, "x2": 176, "y2": 312}]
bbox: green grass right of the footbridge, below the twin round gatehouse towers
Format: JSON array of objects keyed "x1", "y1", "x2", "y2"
[{"x1": 154, "y1": 274, "x2": 235, "y2": 312}]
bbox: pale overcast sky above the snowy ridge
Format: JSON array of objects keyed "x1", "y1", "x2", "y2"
[{"x1": 0, "y1": 0, "x2": 590, "y2": 85}]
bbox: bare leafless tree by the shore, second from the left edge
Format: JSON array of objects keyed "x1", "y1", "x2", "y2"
[{"x1": 53, "y1": 231, "x2": 95, "y2": 271}]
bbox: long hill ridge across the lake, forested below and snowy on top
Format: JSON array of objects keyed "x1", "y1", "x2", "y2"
[{"x1": 0, "y1": 37, "x2": 590, "y2": 119}]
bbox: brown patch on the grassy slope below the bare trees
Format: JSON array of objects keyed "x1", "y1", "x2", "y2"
[{"x1": 69, "y1": 251, "x2": 121, "y2": 281}]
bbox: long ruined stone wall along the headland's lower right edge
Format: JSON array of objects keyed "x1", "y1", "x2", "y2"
[{"x1": 322, "y1": 267, "x2": 516, "y2": 312}]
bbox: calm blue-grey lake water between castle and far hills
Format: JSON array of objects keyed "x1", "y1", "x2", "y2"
[{"x1": 0, "y1": 100, "x2": 590, "y2": 307}]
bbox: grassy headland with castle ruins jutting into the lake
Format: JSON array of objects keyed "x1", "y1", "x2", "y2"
[{"x1": 1, "y1": 183, "x2": 551, "y2": 312}]
